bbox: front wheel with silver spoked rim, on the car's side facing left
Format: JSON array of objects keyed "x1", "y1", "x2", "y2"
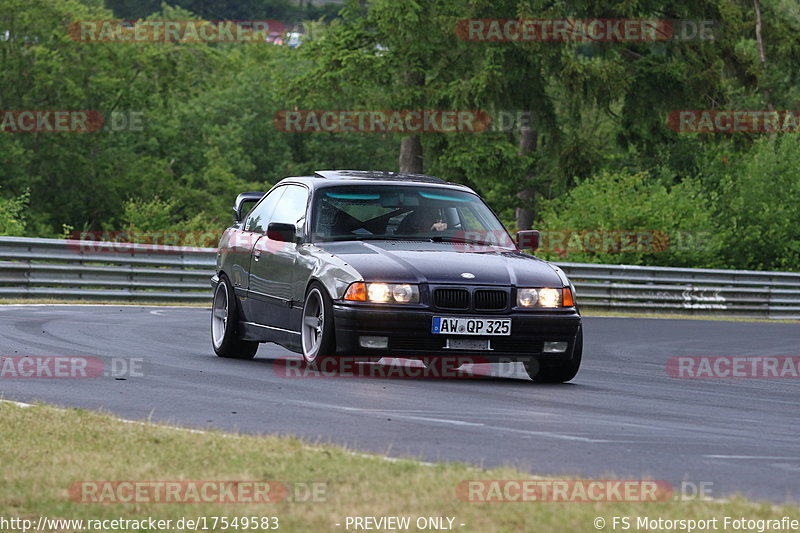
[{"x1": 300, "y1": 281, "x2": 336, "y2": 366}]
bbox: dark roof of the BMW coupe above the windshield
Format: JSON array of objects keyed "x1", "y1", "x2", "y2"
[{"x1": 279, "y1": 170, "x2": 474, "y2": 193}]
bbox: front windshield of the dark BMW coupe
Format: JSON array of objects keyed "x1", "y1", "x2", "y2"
[{"x1": 312, "y1": 185, "x2": 515, "y2": 249}]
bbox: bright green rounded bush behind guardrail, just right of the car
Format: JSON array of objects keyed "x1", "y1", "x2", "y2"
[{"x1": 537, "y1": 171, "x2": 722, "y2": 267}]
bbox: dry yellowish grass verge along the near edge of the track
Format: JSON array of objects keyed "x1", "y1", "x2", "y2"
[{"x1": 0, "y1": 402, "x2": 798, "y2": 533}]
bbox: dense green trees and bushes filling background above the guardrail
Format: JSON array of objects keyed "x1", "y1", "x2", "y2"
[{"x1": 0, "y1": 0, "x2": 800, "y2": 270}]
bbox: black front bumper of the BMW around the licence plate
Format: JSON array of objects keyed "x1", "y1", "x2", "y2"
[{"x1": 333, "y1": 302, "x2": 581, "y2": 361}]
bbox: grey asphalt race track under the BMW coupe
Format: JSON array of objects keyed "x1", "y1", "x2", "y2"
[{"x1": 0, "y1": 306, "x2": 800, "y2": 502}]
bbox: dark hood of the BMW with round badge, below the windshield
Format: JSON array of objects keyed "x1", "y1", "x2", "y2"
[{"x1": 317, "y1": 241, "x2": 563, "y2": 287}]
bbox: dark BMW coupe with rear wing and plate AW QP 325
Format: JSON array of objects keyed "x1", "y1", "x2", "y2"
[{"x1": 211, "y1": 170, "x2": 583, "y2": 382}]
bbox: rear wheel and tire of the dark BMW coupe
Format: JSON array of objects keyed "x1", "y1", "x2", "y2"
[{"x1": 211, "y1": 274, "x2": 258, "y2": 359}]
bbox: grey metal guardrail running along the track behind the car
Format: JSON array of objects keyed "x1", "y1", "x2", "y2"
[{"x1": 0, "y1": 237, "x2": 800, "y2": 319}]
